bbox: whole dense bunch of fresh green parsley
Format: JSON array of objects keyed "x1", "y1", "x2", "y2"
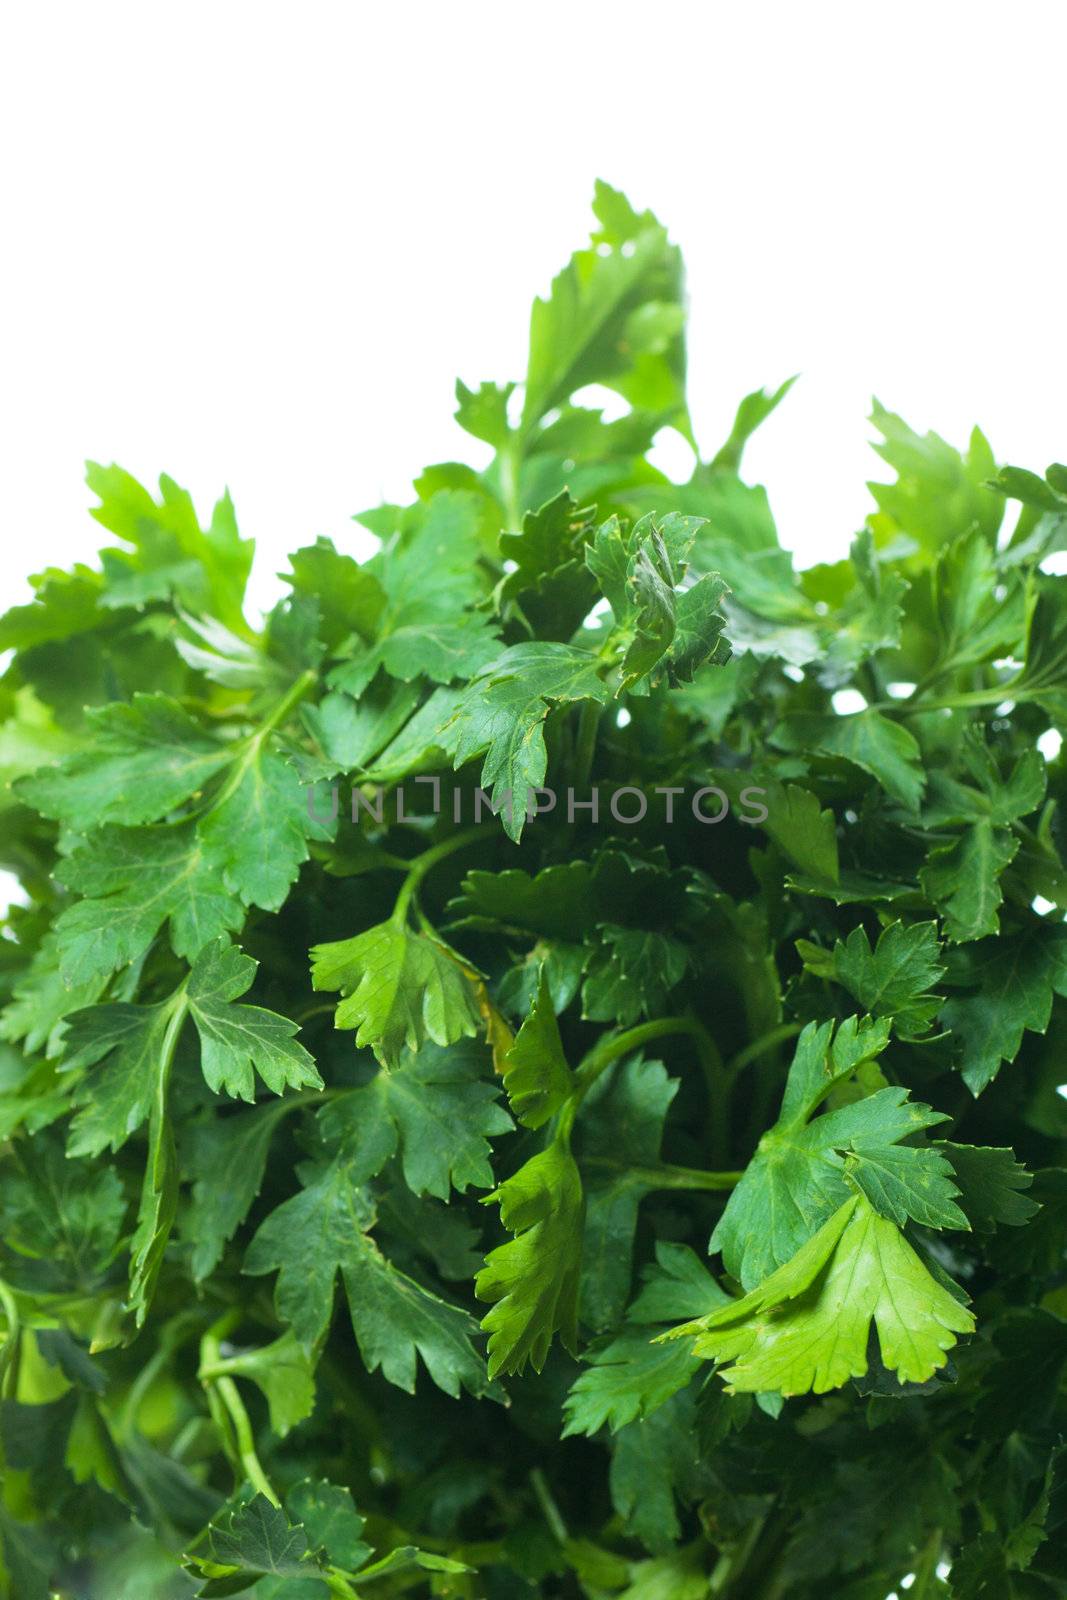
[{"x1": 0, "y1": 186, "x2": 1067, "y2": 1600}]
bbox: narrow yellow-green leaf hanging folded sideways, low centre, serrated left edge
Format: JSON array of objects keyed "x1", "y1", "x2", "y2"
[{"x1": 475, "y1": 1141, "x2": 582, "y2": 1378}]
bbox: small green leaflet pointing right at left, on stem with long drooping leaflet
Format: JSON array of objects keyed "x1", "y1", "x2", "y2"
[{"x1": 186, "y1": 939, "x2": 323, "y2": 1101}]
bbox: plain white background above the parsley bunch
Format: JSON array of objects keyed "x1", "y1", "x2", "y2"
[{"x1": 0, "y1": 0, "x2": 1067, "y2": 617}]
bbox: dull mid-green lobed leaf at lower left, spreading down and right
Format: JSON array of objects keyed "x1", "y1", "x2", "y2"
[{"x1": 245, "y1": 1158, "x2": 486, "y2": 1397}]
